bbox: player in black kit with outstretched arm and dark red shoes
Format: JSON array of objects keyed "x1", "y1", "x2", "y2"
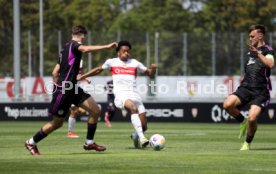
[{"x1": 25, "y1": 25, "x2": 117, "y2": 155}]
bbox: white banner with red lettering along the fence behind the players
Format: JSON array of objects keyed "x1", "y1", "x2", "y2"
[{"x1": 0, "y1": 76, "x2": 276, "y2": 102}]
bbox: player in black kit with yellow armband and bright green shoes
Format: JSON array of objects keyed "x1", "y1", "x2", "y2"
[{"x1": 223, "y1": 24, "x2": 274, "y2": 150}]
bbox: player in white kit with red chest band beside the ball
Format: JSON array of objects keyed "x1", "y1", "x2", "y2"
[{"x1": 78, "y1": 41, "x2": 157, "y2": 147}]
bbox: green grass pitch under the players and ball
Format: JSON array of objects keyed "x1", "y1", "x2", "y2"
[{"x1": 0, "y1": 121, "x2": 276, "y2": 174}]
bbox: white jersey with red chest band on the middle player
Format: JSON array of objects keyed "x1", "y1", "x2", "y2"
[{"x1": 102, "y1": 58, "x2": 147, "y2": 95}]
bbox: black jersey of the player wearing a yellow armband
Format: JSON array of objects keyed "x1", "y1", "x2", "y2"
[{"x1": 241, "y1": 45, "x2": 274, "y2": 89}]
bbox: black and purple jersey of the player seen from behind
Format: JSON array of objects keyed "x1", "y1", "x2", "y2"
[{"x1": 58, "y1": 40, "x2": 82, "y2": 86}]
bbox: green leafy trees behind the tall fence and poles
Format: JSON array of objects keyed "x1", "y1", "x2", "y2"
[{"x1": 0, "y1": 0, "x2": 276, "y2": 76}]
